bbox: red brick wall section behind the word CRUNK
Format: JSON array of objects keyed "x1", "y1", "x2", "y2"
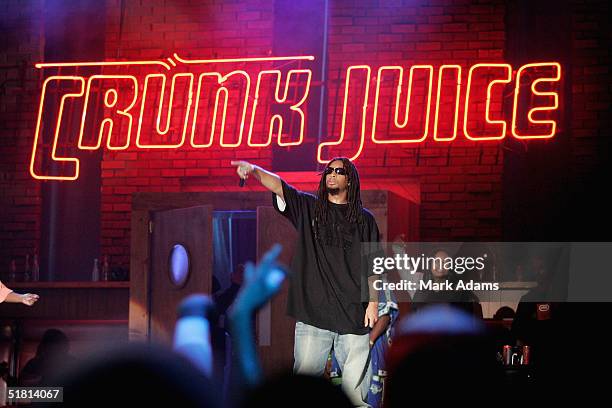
[{"x1": 102, "y1": 0, "x2": 274, "y2": 266}]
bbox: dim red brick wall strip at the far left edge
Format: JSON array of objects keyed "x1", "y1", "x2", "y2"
[{"x1": 0, "y1": 0, "x2": 44, "y2": 274}]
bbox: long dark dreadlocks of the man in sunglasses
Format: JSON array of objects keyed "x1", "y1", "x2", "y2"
[{"x1": 315, "y1": 157, "x2": 363, "y2": 231}]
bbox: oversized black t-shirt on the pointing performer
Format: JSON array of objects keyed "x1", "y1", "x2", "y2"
[{"x1": 272, "y1": 181, "x2": 379, "y2": 334}]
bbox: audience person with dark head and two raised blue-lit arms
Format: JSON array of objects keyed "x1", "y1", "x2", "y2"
[{"x1": 47, "y1": 245, "x2": 286, "y2": 408}]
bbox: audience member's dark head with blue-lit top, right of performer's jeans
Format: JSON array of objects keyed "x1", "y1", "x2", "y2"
[{"x1": 385, "y1": 305, "x2": 502, "y2": 408}]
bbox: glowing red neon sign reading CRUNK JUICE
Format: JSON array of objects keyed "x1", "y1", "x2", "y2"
[{"x1": 30, "y1": 54, "x2": 561, "y2": 180}]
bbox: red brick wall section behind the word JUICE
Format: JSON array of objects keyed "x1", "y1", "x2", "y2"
[{"x1": 329, "y1": 1, "x2": 504, "y2": 240}]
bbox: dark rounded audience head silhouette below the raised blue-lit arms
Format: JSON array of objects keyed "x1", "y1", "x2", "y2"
[{"x1": 49, "y1": 343, "x2": 220, "y2": 408}]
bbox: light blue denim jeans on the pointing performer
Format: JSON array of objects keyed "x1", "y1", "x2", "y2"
[{"x1": 293, "y1": 322, "x2": 371, "y2": 407}]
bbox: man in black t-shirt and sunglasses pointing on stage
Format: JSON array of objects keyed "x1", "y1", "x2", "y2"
[{"x1": 232, "y1": 157, "x2": 379, "y2": 406}]
